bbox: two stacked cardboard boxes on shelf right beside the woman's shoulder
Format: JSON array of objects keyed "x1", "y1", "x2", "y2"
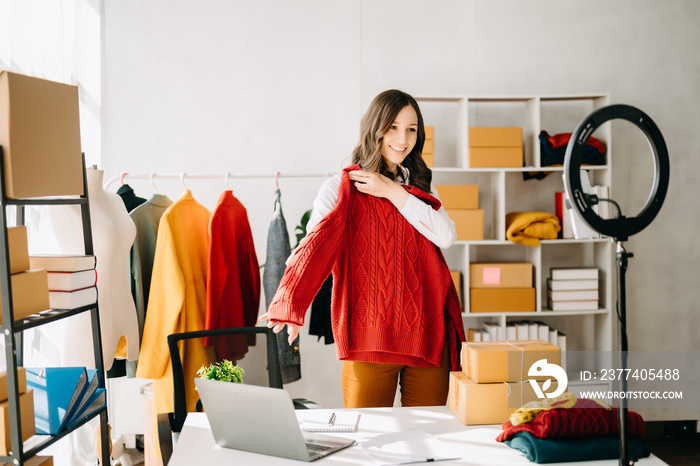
[{"x1": 435, "y1": 184, "x2": 484, "y2": 241}]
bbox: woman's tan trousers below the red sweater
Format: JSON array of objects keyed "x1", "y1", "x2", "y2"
[{"x1": 342, "y1": 348, "x2": 450, "y2": 408}]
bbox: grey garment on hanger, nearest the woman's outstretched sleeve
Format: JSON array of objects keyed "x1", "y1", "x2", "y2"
[{"x1": 263, "y1": 189, "x2": 301, "y2": 383}]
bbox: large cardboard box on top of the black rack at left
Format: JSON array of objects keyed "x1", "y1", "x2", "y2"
[{"x1": 0, "y1": 71, "x2": 83, "y2": 199}]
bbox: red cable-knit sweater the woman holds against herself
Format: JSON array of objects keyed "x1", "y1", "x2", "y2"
[{"x1": 268, "y1": 165, "x2": 465, "y2": 370}]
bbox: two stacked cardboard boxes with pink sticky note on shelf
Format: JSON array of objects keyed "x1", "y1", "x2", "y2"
[{"x1": 469, "y1": 262, "x2": 535, "y2": 312}]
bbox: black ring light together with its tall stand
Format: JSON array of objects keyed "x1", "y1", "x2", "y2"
[{"x1": 564, "y1": 105, "x2": 670, "y2": 466}]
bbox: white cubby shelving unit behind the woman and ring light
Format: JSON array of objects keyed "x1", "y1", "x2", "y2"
[{"x1": 416, "y1": 94, "x2": 615, "y2": 386}]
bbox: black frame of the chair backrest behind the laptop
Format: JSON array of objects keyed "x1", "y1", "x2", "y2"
[{"x1": 168, "y1": 327, "x2": 282, "y2": 432}]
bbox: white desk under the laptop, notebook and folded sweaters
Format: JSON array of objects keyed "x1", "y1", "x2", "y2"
[{"x1": 168, "y1": 407, "x2": 666, "y2": 466}]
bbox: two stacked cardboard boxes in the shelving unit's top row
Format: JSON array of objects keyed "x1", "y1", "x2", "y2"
[{"x1": 469, "y1": 127, "x2": 523, "y2": 168}]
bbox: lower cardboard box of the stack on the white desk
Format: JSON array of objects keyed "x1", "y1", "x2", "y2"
[{"x1": 448, "y1": 377, "x2": 557, "y2": 426}]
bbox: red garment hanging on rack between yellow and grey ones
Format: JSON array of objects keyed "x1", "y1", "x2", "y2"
[{"x1": 204, "y1": 190, "x2": 260, "y2": 361}]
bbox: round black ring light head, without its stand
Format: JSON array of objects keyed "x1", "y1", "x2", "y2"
[{"x1": 564, "y1": 104, "x2": 670, "y2": 241}]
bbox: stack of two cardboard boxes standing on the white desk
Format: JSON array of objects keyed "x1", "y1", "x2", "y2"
[{"x1": 447, "y1": 340, "x2": 560, "y2": 425}]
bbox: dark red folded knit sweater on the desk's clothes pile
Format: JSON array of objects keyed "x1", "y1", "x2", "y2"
[{"x1": 496, "y1": 398, "x2": 646, "y2": 442}]
